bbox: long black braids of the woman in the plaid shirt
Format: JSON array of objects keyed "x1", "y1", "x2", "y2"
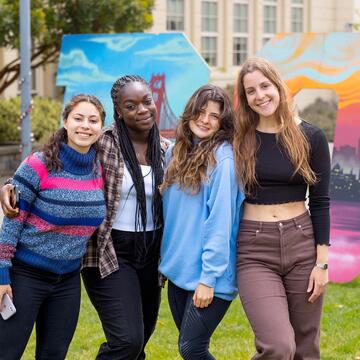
[{"x1": 111, "y1": 75, "x2": 164, "y2": 232}]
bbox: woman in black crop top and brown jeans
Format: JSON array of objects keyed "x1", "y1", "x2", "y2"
[{"x1": 234, "y1": 58, "x2": 330, "y2": 360}]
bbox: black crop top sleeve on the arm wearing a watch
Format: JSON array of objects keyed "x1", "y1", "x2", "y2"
[{"x1": 309, "y1": 129, "x2": 331, "y2": 245}]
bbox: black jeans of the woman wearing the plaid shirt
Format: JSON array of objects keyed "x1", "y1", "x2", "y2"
[{"x1": 82, "y1": 230, "x2": 161, "y2": 360}]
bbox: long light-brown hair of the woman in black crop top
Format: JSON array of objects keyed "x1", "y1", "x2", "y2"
[{"x1": 233, "y1": 57, "x2": 317, "y2": 195}]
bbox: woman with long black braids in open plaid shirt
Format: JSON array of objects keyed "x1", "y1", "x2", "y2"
[{"x1": 2, "y1": 75, "x2": 169, "y2": 360}]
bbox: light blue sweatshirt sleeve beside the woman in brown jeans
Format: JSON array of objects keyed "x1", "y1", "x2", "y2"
[{"x1": 199, "y1": 157, "x2": 240, "y2": 287}]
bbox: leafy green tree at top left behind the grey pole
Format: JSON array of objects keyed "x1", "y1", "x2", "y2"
[{"x1": 0, "y1": 0, "x2": 154, "y2": 93}]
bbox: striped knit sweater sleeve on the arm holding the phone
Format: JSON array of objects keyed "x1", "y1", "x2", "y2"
[{"x1": 0, "y1": 155, "x2": 42, "y2": 285}]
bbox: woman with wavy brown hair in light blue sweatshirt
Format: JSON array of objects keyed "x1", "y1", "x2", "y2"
[{"x1": 160, "y1": 85, "x2": 243, "y2": 360}]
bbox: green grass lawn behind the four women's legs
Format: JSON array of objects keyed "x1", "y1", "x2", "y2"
[{"x1": 23, "y1": 277, "x2": 360, "y2": 360}]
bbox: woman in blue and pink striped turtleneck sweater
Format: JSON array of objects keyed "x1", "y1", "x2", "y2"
[{"x1": 0, "y1": 95, "x2": 105, "y2": 360}]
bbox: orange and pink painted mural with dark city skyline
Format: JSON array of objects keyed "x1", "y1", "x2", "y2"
[{"x1": 258, "y1": 33, "x2": 360, "y2": 282}]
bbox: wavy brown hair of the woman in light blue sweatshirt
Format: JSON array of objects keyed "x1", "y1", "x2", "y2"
[{"x1": 160, "y1": 85, "x2": 235, "y2": 194}]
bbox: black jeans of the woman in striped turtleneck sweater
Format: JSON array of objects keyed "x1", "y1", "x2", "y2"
[{"x1": 0, "y1": 260, "x2": 80, "y2": 360}]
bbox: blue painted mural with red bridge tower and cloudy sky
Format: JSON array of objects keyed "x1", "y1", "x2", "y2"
[{"x1": 56, "y1": 33, "x2": 209, "y2": 137}]
